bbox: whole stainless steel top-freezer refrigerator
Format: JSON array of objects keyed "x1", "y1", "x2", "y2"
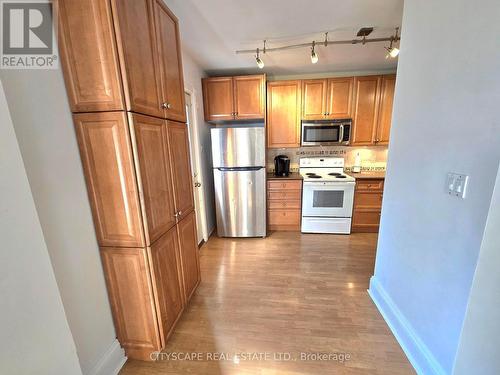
[{"x1": 212, "y1": 127, "x2": 266, "y2": 237}]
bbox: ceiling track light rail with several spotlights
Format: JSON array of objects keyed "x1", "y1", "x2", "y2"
[{"x1": 239, "y1": 27, "x2": 401, "y2": 69}]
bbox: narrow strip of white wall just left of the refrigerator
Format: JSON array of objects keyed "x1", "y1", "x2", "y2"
[{"x1": 179, "y1": 43, "x2": 215, "y2": 234}]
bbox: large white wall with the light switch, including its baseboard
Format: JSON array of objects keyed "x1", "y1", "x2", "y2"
[{"x1": 370, "y1": 0, "x2": 500, "y2": 373}]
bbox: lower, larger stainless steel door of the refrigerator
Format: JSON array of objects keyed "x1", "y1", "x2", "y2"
[{"x1": 214, "y1": 168, "x2": 266, "y2": 237}]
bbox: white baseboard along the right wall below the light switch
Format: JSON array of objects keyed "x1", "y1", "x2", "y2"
[{"x1": 368, "y1": 276, "x2": 446, "y2": 375}]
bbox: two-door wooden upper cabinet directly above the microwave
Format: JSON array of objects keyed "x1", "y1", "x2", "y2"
[{"x1": 302, "y1": 77, "x2": 354, "y2": 120}]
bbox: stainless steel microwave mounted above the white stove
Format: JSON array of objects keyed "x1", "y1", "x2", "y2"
[{"x1": 300, "y1": 119, "x2": 352, "y2": 146}]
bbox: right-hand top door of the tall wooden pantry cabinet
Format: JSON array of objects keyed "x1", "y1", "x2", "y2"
[{"x1": 155, "y1": 0, "x2": 186, "y2": 122}]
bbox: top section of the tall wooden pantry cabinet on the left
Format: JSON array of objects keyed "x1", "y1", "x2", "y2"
[{"x1": 58, "y1": 0, "x2": 186, "y2": 121}]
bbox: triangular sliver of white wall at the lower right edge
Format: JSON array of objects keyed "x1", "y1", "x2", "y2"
[{"x1": 454, "y1": 169, "x2": 500, "y2": 375}]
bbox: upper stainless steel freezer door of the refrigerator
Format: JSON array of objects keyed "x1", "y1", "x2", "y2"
[{"x1": 212, "y1": 127, "x2": 266, "y2": 168}]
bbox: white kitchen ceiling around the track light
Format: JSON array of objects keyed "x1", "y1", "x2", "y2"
[{"x1": 164, "y1": 0, "x2": 403, "y2": 75}]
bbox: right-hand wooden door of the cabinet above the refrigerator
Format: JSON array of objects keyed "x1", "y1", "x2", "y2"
[{"x1": 233, "y1": 75, "x2": 266, "y2": 120}]
